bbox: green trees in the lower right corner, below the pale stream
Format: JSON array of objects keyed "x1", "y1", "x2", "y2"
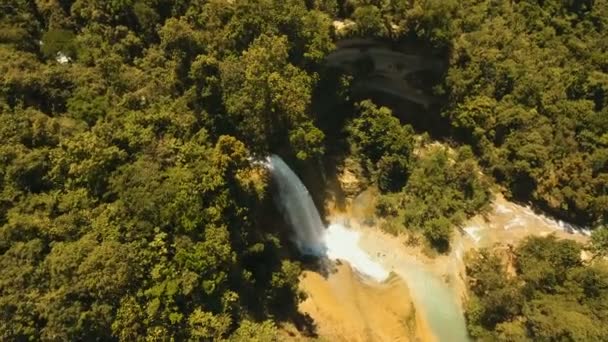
[{"x1": 466, "y1": 236, "x2": 608, "y2": 341}]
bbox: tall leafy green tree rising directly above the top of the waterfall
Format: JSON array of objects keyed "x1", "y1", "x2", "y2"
[{"x1": 220, "y1": 35, "x2": 323, "y2": 158}]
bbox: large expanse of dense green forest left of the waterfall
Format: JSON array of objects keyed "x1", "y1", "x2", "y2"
[{"x1": 0, "y1": 0, "x2": 333, "y2": 341}]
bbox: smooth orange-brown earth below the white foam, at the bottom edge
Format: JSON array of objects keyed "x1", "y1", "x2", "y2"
[{"x1": 300, "y1": 264, "x2": 435, "y2": 342}]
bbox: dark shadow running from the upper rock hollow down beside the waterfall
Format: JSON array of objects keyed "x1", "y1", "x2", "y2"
[{"x1": 304, "y1": 38, "x2": 451, "y2": 217}]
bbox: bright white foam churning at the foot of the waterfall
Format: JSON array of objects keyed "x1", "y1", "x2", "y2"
[{"x1": 324, "y1": 223, "x2": 389, "y2": 282}]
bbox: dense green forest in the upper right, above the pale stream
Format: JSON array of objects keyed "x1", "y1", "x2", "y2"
[{"x1": 445, "y1": 1, "x2": 608, "y2": 225}]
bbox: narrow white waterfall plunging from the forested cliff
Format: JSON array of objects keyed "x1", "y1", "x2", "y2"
[{"x1": 267, "y1": 154, "x2": 325, "y2": 256}]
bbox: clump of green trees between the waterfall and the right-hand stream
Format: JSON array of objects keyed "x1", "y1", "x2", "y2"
[{"x1": 346, "y1": 101, "x2": 490, "y2": 251}]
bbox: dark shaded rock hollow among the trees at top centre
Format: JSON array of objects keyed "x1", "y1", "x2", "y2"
[{"x1": 324, "y1": 39, "x2": 450, "y2": 138}]
